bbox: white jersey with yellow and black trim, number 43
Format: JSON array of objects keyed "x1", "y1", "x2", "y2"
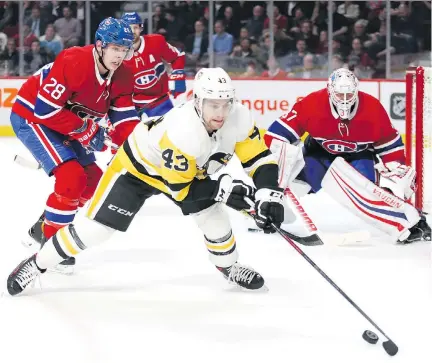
[{"x1": 115, "y1": 101, "x2": 277, "y2": 201}]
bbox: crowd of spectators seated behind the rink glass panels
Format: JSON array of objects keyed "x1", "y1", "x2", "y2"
[{"x1": 0, "y1": 0, "x2": 431, "y2": 79}]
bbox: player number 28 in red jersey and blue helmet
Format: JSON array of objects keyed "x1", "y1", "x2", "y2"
[{"x1": 11, "y1": 18, "x2": 139, "y2": 272}]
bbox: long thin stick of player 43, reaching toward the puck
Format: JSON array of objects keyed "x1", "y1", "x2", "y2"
[{"x1": 271, "y1": 219, "x2": 399, "y2": 356}]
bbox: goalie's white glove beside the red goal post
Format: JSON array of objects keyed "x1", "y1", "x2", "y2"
[{"x1": 375, "y1": 160, "x2": 417, "y2": 200}]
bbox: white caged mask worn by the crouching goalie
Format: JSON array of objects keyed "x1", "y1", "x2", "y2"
[{"x1": 327, "y1": 68, "x2": 358, "y2": 119}]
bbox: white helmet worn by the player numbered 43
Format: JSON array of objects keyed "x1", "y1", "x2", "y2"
[{"x1": 193, "y1": 68, "x2": 235, "y2": 118}]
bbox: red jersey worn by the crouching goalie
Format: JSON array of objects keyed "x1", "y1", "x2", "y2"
[{"x1": 264, "y1": 89, "x2": 405, "y2": 164}]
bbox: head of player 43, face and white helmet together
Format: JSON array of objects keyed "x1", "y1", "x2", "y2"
[{"x1": 193, "y1": 68, "x2": 234, "y2": 131}]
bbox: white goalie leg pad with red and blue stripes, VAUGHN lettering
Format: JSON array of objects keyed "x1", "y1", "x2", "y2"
[{"x1": 322, "y1": 157, "x2": 420, "y2": 241}]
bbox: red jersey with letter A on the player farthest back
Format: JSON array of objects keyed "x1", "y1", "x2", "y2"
[{"x1": 123, "y1": 34, "x2": 185, "y2": 107}]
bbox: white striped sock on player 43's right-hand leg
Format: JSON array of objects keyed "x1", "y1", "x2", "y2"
[{"x1": 192, "y1": 203, "x2": 238, "y2": 267}]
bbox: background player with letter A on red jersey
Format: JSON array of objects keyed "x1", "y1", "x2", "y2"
[{"x1": 110, "y1": 12, "x2": 186, "y2": 144}]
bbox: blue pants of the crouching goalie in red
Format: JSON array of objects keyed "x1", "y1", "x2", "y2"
[{"x1": 297, "y1": 137, "x2": 378, "y2": 193}]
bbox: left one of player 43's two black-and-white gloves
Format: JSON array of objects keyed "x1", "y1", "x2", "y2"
[{"x1": 213, "y1": 174, "x2": 255, "y2": 210}]
